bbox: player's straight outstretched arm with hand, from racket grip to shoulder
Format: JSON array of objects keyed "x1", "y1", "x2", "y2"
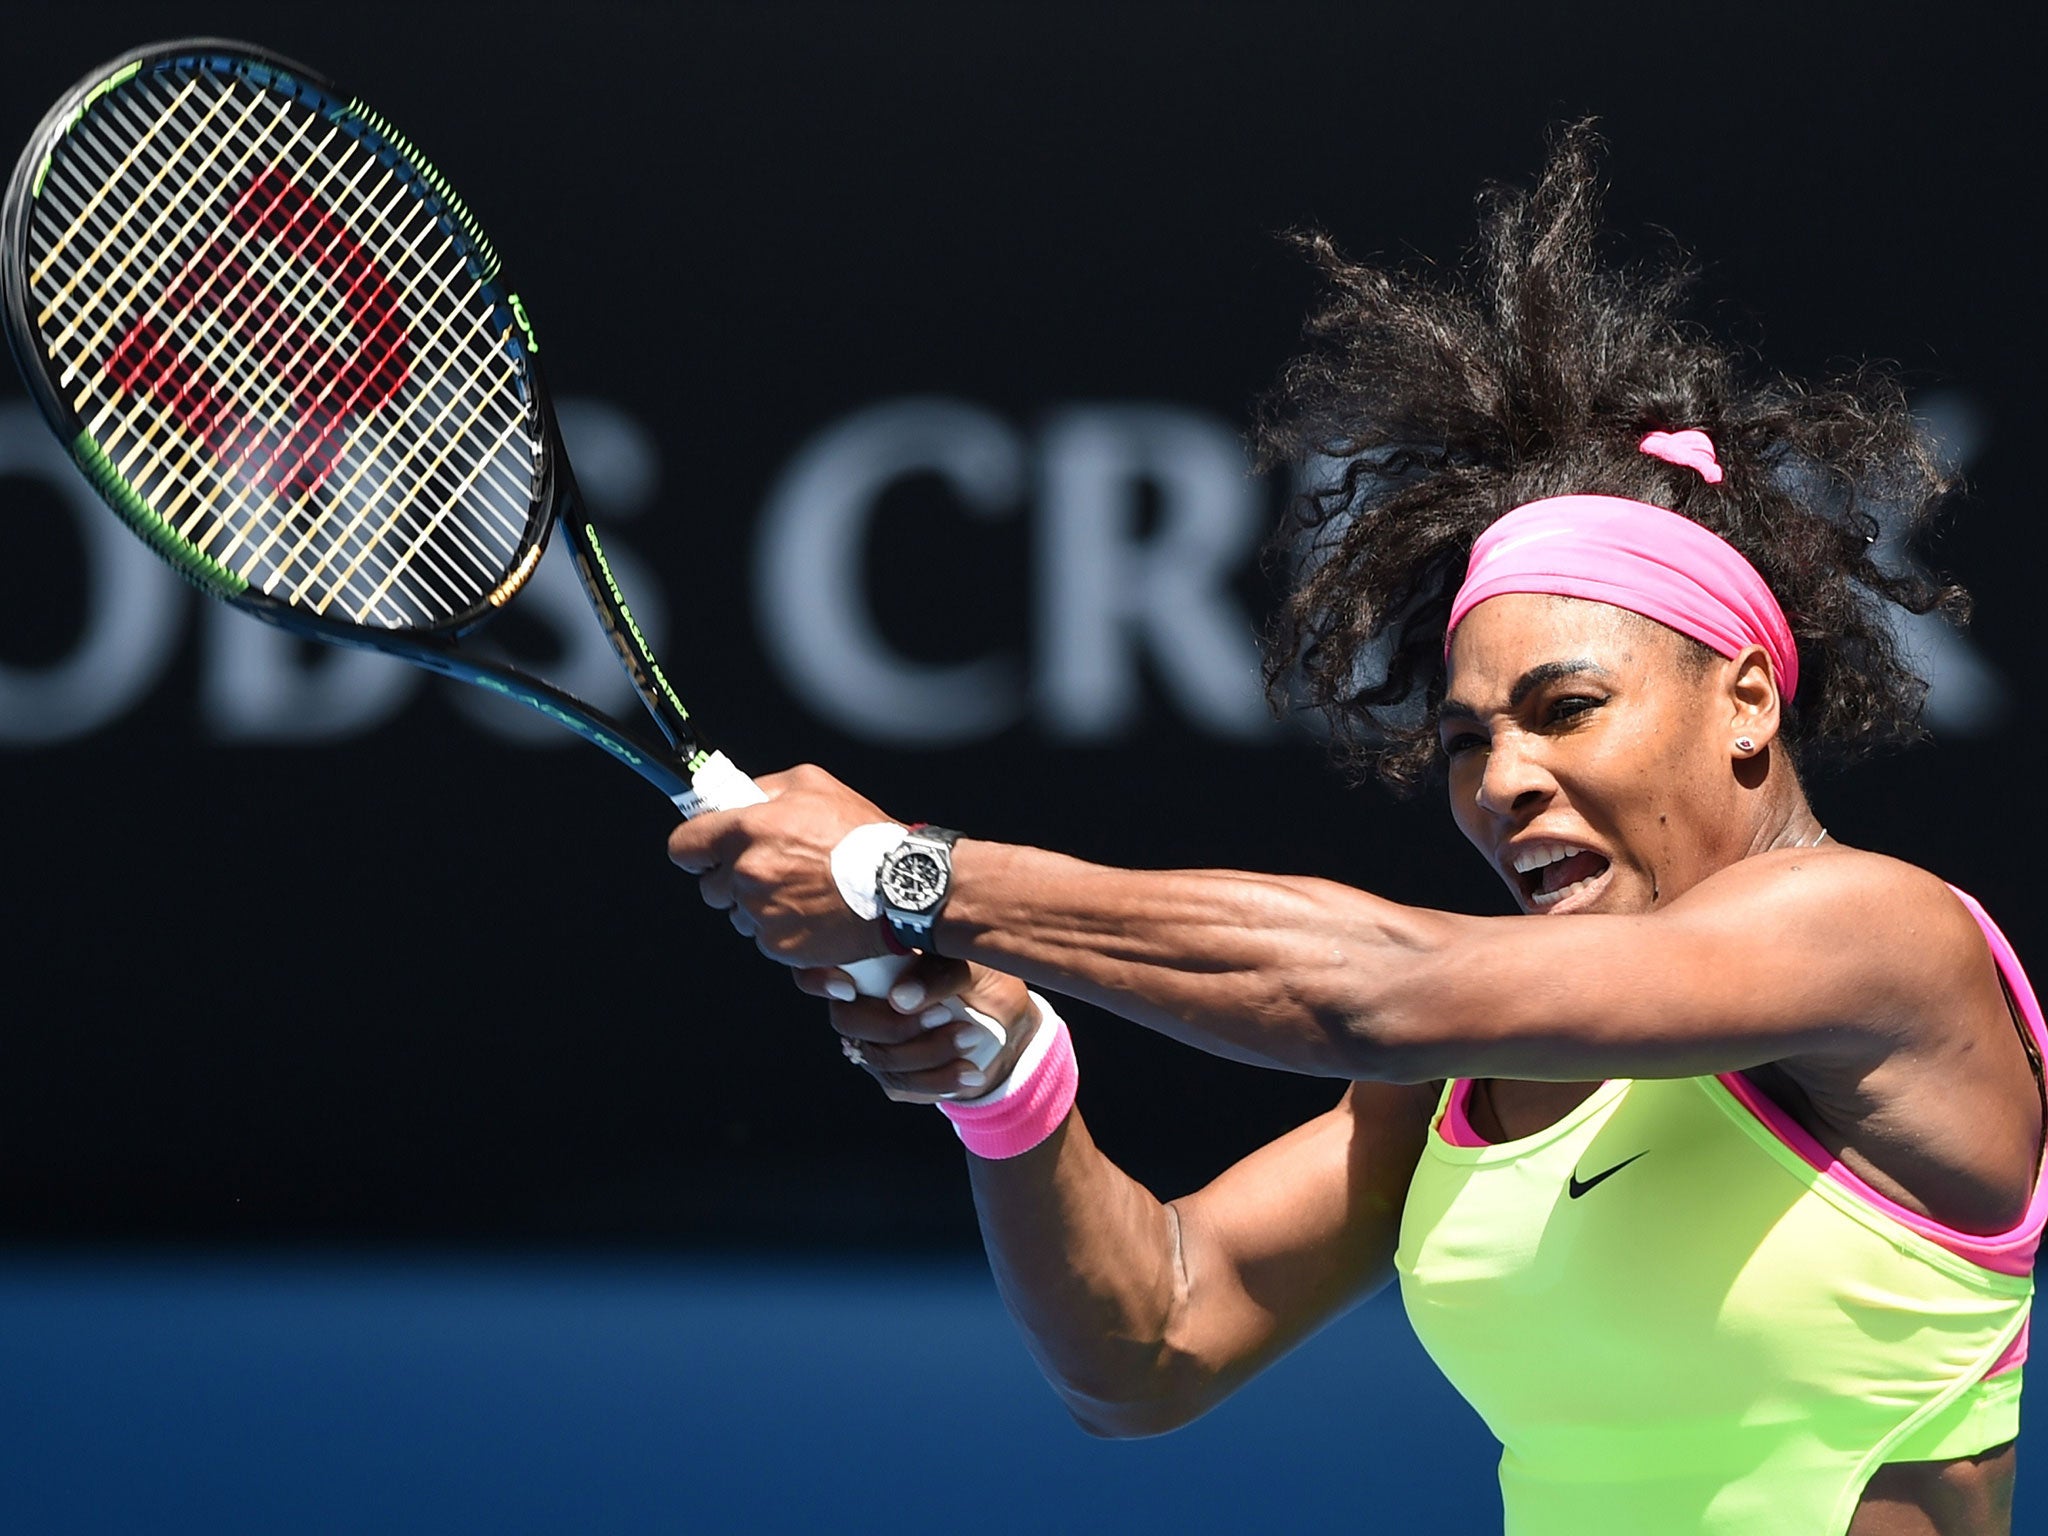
[{"x1": 670, "y1": 770, "x2": 1982, "y2": 1083}]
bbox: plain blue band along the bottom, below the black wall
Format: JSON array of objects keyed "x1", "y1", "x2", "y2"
[{"x1": 0, "y1": 1251, "x2": 1499, "y2": 1536}]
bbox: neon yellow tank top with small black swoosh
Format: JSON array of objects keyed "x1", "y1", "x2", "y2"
[{"x1": 1395, "y1": 903, "x2": 2044, "y2": 1536}]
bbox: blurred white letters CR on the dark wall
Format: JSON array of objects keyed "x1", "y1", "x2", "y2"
[{"x1": 754, "y1": 399, "x2": 1272, "y2": 745}]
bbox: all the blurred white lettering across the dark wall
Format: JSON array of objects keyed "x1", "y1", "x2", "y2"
[{"x1": 0, "y1": 393, "x2": 2007, "y2": 750}]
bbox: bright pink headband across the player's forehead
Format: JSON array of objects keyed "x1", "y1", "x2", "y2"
[{"x1": 1444, "y1": 499, "x2": 1798, "y2": 698}]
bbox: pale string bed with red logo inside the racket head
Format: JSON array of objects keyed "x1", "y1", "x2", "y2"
[{"x1": 35, "y1": 60, "x2": 541, "y2": 623}]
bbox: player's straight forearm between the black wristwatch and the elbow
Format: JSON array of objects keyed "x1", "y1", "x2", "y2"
[{"x1": 936, "y1": 840, "x2": 1449, "y2": 1079}]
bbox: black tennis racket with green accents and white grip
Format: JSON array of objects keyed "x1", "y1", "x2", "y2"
[{"x1": 0, "y1": 39, "x2": 1004, "y2": 1067}]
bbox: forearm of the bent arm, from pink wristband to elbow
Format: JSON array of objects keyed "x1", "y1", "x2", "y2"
[{"x1": 969, "y1": 1112, "x2": 1210, "y2": 1436}]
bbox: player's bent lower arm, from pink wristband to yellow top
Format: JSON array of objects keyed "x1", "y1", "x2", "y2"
[{"x1": 973, "y1": 1083, "x2": 1440, "y2": 1436}]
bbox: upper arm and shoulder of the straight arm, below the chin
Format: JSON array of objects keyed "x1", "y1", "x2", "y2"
[{"x1": 1358, "y1": 846, "x2": 1997, "y2": 1106}]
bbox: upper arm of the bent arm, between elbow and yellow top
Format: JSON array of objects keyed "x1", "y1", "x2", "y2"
[{"x1": 1169, "y1": 1083, "x2": 1436, "y2": 1397}]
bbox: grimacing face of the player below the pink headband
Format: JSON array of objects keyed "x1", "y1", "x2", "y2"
[{"x1": 1438, "y1": 594, "x2": 1776, "y2": 915}]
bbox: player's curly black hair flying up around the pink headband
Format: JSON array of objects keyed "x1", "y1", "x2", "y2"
[{"x1": 1255, "y1": 123, "x2": 1968, "y2": 788}]
